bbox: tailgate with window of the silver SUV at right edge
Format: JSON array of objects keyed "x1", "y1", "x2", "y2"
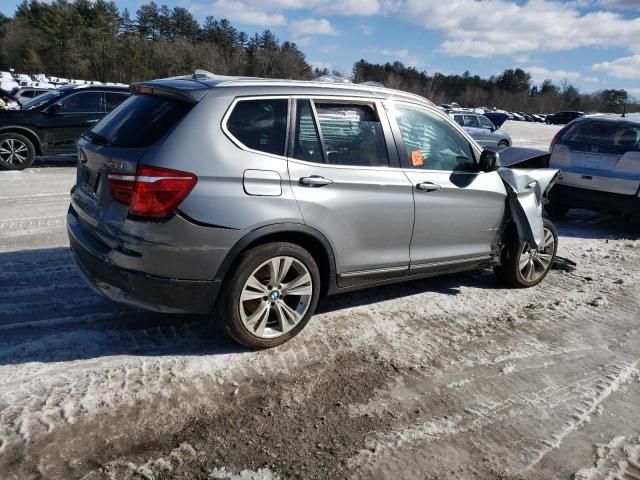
[{"x1": 550, "y1": 119, "x2": 640, "y2": 195}]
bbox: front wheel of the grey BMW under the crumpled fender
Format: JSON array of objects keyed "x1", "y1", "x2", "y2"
[{"x1": 494, "y1": 218, "x2": 558, "y2": 288}]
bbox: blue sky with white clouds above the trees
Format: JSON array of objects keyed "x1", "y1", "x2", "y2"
[{"x1": 0, "y1": 0, "x2": 640, "y2": 98}]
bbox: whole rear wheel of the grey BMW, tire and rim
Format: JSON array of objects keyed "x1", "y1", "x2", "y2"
[{"x1": 216, "y1": 242, "x2": 320, "y2": 348}]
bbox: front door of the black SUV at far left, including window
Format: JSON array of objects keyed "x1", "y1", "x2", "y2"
[{"x1": 42, "y1": 92, "x2": 104, "y2": 153}]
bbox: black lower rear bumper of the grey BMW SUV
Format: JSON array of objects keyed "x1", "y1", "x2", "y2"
[{"x1": 67, "y1": 209, "x2": 220, "y2": 314}]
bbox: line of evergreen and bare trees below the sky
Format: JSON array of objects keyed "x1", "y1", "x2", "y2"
[{"x1": 0, "y1": 0, "x2": 639, "y2": 113}]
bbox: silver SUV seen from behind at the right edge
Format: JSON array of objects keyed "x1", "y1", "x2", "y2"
[{"x1": 546, "y1": 116, "x2": 640, "y2": 217}]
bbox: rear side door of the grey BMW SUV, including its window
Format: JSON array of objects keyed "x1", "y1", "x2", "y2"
[{"x1": 288, "y1": 98, "x2": 413, "y2": 285}]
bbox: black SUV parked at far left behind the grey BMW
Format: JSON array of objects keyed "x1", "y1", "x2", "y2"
[{"x1": 0, "y1": 86, "x2": 130, "y2": 170}]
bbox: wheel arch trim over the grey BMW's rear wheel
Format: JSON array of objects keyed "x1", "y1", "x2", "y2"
[{"x1": 214, "y1": 223, "x2": 337, "y2": 296}]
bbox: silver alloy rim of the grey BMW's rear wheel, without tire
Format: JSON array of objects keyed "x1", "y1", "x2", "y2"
[{"x1": 238, "y1": 256, "x2": 313, "y2": 338}]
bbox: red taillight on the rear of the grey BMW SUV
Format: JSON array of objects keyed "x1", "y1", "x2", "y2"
[{"x1": 109, "y1": 165, "x2": 198, "y2": 218}]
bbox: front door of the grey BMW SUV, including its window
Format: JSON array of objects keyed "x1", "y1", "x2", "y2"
[{"x1": 389, "y1": 102, "x2": 506, "y2": 270}]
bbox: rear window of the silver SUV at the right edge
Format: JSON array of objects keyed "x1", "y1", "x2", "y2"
[{"x1": 558, "y1": 121, "x2": 640, "y2": 155}]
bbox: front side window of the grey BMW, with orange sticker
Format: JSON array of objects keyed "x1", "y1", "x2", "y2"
[{"x1": 395, "y1": 106, "x2": 475, "y2": 170}]
